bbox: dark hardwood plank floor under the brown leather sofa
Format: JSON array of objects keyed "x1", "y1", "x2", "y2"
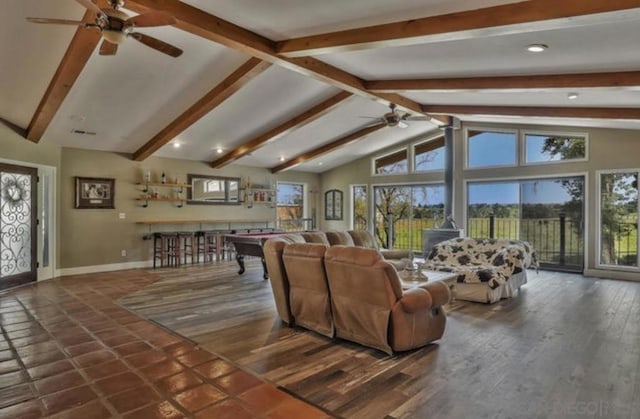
[{"x1": 119, "y1": 261, "x2": 640, "y2": 418}]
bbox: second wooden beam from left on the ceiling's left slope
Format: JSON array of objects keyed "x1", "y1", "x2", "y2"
[{"x1": 133, "y1": 58, "x2": 271, "y2": 161}]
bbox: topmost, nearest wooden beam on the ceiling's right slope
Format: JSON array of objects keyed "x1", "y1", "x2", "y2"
[{"x1": 277, "y1": 0, "x2": 640, "y2": 57}]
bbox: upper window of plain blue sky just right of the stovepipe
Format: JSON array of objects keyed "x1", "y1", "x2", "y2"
[{"x1": 467, "y1": 129, "x2": 518, "y2": 169}]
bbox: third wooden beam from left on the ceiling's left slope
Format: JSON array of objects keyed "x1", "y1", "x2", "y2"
[{"x1": 211, "y1": 91, "x2": 353, "y2": 169}]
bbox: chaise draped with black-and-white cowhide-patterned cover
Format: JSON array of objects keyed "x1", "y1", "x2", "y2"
[{"x1": 423, "y1": 237, "x2": 538, "y2": 303}]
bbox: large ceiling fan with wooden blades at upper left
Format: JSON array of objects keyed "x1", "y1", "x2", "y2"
[{"x1": 27, "y1": 0, "x2": 182, "y2": 57}]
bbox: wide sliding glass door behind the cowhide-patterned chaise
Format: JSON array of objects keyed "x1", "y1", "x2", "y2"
[{"x1": 467, "y1": 176, "x2": 585, "y2": 272}]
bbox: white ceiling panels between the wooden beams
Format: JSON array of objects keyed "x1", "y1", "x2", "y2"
[{"x1": 0, "y1": 0, "x2": 640, "y2": 172}]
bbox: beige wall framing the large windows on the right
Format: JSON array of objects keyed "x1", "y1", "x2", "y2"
[{"x1": 321, "y1": 124, "x2": 640, "y2": 276}]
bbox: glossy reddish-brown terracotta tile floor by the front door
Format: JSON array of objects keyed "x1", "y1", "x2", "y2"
[{"x1": 0, "y1": 270, "x2": 332, "y2": 419}]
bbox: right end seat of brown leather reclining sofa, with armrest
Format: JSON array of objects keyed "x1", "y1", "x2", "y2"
[{"x1": 325, "y1": 245, "x2": 451, "y2": 354}]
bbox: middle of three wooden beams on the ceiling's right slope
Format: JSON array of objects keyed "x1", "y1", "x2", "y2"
[{"x1": 365, "y1": 71, "x2": 640, "y2": 92}]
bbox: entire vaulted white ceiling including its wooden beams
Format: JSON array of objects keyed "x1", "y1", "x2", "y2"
[{"x1": 0, "y1": 0, "x2": 640, "y2": 172}]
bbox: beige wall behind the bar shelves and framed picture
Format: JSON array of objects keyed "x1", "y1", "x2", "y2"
[{"x1": 60, "y1": 148, "x2": 319, "y2": 268}]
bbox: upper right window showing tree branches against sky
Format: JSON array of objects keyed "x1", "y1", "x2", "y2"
[{"x1": 524, "y1": 133, "x2": 587, "y2": 163}]
